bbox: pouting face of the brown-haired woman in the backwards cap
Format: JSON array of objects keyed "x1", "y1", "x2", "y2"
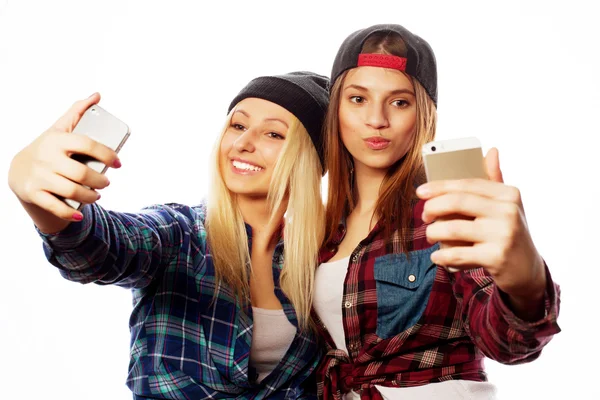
[{"x1": 338, "y1": 67, "x2": 417, "y2": 170}]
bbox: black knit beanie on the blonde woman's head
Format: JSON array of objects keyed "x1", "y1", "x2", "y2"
[{"x1": 227, "y1": 71, "x2": 329, "y2": 168}]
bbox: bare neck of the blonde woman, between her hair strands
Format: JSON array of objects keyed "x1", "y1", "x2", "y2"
[{"x1": 237, "y1": 196, "x2": 285, "y2": 248}]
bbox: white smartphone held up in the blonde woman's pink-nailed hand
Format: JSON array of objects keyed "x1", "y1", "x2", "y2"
[{"x1": 63, "y1": 104, "x2": 130, "y2": 210}]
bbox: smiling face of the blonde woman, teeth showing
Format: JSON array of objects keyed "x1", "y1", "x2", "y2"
[{"x1": 219, "y1": 98, "x2": 294, "y2": 198}]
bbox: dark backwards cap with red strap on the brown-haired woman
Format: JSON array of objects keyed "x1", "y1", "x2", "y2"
[{"x1": 331, "y1": 24, "x2": 437, "y2": 106}]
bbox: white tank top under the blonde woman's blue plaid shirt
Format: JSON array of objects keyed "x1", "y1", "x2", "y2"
[{"x1": 250, "y1": 307, "x2": 296, "y2": 382}]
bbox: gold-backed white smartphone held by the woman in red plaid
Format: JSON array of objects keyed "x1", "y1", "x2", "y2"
[{"x1": 421, "y1": 137, "x2": 488, "y2": 272}]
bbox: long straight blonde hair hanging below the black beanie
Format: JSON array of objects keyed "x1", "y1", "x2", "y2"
[{"x1": 206, "y1": 107, "x2": 325, "y2": 328}]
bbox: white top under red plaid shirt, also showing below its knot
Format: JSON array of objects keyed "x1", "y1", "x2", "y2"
[{"x1": 313, "y1": 256, "x2": 496, "y2": 400}]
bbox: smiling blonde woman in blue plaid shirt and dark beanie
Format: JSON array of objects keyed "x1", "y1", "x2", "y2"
[{"x1": 9, "y1": 72, "x2": 328, "y2": 400}]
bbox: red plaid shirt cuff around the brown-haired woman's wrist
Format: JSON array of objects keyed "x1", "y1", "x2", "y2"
[{"x1": 491, "y1": 262, "x2": 560, "y2": 332}]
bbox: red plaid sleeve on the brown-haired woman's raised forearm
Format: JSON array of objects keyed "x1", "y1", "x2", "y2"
[{"x1": 453, "y1": 266, "x2": 560, "y2": 364}]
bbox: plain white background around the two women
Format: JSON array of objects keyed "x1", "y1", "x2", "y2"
[{"x1": 0, "y1": 0, "x2": 600, "y2": 400}]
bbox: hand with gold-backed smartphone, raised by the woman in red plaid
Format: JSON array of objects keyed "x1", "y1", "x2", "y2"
[{"x1": 417, "y1": 138, "x2": 547, "y2": 304}]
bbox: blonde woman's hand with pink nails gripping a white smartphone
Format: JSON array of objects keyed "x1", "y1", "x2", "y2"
[{"x1": 8, "y1": 93, "x2": 129, "y2": 225}]
